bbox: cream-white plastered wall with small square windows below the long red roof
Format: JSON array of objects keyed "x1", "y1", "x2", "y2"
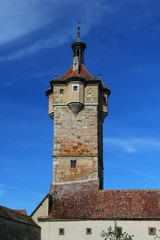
[{"x1": 39, "y1": 220, "x2": 160, "y2": 240}]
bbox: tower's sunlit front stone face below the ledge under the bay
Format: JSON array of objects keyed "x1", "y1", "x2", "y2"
[{"x1": 53, "y1": 106, "x2": 98, "y2": 182}]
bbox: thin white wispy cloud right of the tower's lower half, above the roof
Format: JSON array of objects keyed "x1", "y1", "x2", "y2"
[{"x1": 104, "y1": 137, "x2": 160, "y2": 153}]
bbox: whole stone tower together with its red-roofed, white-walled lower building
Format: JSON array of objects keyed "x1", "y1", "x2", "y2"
[{"x1": 31, "y1": 29, "x2": 160, "y2": 240}]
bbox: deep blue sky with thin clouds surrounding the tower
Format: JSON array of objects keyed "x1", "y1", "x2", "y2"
[{"x1": 0, "y1": 0, "x2": 160, "y2": 214}]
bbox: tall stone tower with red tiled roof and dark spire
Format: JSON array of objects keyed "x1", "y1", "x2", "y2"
[{"x1": 46, "y1": 27, "x2": 110, "y2": 189}]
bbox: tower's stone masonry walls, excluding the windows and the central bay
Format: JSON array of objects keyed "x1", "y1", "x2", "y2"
[{"x1": 53, "y1": 83, "x2": 103, "y2": 188}]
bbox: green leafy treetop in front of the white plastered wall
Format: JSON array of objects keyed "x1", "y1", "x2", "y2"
[{"x1": 101, "y1": 222, "x2": 134, "y2": 240}]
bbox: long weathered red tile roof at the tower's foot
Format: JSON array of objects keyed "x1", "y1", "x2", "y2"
[{"x1": 49, "y1": 181, "x2": 160, "y2": 219}]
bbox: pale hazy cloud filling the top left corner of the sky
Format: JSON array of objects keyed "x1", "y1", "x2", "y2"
[{"x1": 0, "y1": 0, "x2": 54, "y2": 44}]
